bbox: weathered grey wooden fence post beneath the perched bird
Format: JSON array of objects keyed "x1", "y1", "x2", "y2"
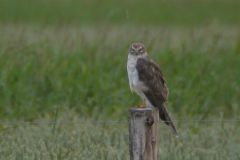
[{"x1": 128, "y1": 107, "x2": 159, "y2": 160}]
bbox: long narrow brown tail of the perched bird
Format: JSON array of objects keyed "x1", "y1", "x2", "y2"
[{"x1": 159, "y1": 104, "x2": 178, "y2": 137}]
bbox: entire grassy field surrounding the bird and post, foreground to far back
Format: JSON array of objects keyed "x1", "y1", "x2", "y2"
[{"x1": 0, "y1": 0, "x2": 240, "y2": 160}]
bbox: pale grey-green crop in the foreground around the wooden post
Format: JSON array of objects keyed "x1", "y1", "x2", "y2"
[{"x1": 0, "y1": 110, "x2": 240, "y2": 160}]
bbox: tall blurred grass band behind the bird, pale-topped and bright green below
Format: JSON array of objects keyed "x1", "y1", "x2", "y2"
[{"x1": 0, "y1": 24, "x2": 240, "y2": 120}]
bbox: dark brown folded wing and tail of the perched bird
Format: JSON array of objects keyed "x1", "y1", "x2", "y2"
[{"x1": 136, "y1": 56, "x2": 177, "y2": 136}]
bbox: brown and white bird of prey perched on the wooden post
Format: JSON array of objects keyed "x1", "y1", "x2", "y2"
[{"x1": 127, "y1": 43, "x2": 178, "y2": 136}]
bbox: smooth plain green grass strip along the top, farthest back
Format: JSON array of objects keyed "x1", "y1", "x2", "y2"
[{"x1": 0, "y1": 0, "x2": 240, "y2": 25}]
